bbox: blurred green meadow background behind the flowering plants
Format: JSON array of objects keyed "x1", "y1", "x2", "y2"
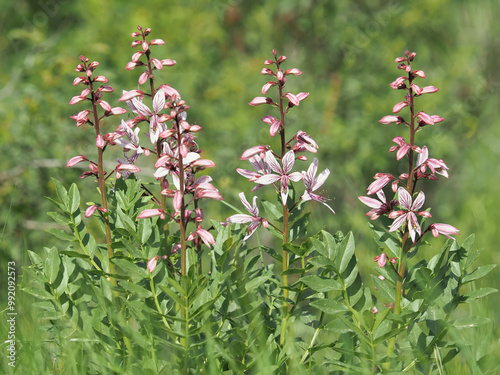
[{"x1": 0, "y1": 0, "x2": 500, "y2": 356}]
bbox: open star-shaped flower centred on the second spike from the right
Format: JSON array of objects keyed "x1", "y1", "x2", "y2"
[{"x1": 255, "y1": 150, "x2": 302, "y2": 205}]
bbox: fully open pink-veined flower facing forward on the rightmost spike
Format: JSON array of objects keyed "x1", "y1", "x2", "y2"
[{"x1": 389, "y1": 187, "x2": 431, "y2": 242}]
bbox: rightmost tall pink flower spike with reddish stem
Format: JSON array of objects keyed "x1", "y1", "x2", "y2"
[{"x1": 359, "y1": 51, "x2": 458, "y2": 360}]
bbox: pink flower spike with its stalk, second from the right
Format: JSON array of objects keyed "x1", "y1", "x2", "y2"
[{"x1": 232, "y1": 50, "x2": 333, "y2": 346}]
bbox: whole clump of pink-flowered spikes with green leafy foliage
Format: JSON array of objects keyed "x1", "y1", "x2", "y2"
[{"x1": 15, "y1": 26, "x2": 495, "y2": 374}]
